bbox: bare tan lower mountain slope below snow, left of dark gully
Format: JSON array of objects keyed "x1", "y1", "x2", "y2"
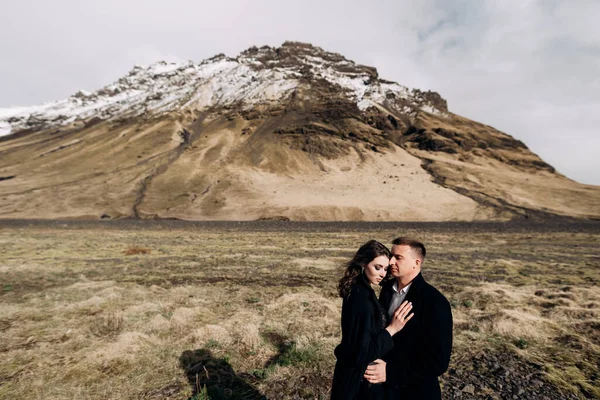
[{"x1": 0, "y1": 108, "x2": 491, "y2": 220}]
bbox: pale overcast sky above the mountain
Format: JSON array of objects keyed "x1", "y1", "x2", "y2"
[{"x1": 0, "y1": 0, "x2": 600, "y2": 185}]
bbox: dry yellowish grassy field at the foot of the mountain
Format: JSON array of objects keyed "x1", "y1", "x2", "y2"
[{"x1": 0, "y1": 221, "x2": 600, "y2": 400}]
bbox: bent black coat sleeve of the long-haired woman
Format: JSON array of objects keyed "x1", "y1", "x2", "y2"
[{"x1": 336, "y1": 293, "x2": 394, "y2": 369}]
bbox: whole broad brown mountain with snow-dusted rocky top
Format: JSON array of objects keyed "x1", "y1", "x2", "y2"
[{"x1": 0, "y1": 42, "x2": 600, "y2": 221}]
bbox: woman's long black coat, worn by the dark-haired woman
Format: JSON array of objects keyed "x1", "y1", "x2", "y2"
[{"x1": 331, "y1": 275, "x2": 394, "y2": 400}]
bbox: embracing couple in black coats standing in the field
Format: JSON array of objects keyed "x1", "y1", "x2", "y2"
[{"x1": 331, "y1": 237, "x2": 452, "y2": 400}]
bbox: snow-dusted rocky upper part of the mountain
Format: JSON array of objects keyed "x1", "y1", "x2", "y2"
[{"x1": 0, "y1": 42, "x2": 445, "y2": 136}]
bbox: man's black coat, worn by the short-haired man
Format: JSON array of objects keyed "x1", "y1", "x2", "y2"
[{"x1": 379, "y1": 274, "x2": 452, "y2": 400}]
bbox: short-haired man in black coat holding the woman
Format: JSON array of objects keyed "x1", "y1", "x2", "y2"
[{"x1": 365, "y1": 237, "x2": 452, "y2": 400}]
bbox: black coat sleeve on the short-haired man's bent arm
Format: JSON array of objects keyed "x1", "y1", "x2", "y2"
[{"x1": 386, "y1": 297, "x2": 452, "y2": 385}]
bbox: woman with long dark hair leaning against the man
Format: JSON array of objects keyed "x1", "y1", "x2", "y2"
[{"x1": 331, "y1": 240, "x2": 413, "y2": 400}]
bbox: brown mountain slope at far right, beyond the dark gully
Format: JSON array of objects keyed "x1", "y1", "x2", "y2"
[{"x1": 406, "y1": 113, "x2": 600, "y2": 218}]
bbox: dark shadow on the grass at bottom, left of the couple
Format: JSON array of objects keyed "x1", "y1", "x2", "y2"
[{"x1": 179, "y1": 349, "x2": 266, "y2": 400}]
